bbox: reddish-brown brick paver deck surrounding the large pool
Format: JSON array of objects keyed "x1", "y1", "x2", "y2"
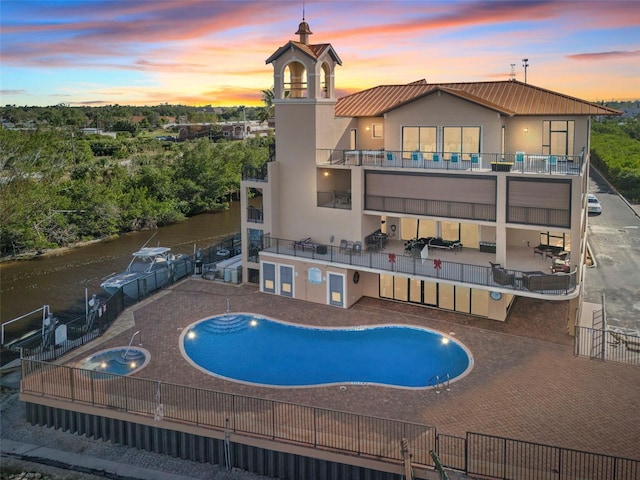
[{"x1": 62, "y1": 278, "x2": 640, "y2": 459}]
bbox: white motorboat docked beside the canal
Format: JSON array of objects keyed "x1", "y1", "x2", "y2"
[{"x1": 100, "y1": 247, "x2": 188, "y2": 300}]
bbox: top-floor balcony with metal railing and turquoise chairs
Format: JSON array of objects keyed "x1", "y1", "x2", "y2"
[{"x1": 316, "y1": 149, "x2": 585, "y2": 175}]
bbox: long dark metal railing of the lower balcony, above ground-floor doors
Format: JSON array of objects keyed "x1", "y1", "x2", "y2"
[{"x1": 262, "y1": 235, "x2": 577, "y2": 295}]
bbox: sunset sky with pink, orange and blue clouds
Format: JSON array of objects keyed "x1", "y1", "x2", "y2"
[{"x1": 0, "y1": 0, "x2": 640, "y2": 106}]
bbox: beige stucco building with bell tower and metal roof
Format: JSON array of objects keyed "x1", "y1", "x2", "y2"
[{"x1": 242, "y1": 21, "x2": 620, "y2": 325}]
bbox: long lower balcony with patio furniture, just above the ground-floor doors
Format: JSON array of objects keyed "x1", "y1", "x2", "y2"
[{"x1": 262, "y1": 236, "x2": 577, "y2": 300}]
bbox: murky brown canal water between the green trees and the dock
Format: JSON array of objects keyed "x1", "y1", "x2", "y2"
[{"x1": 0, "y1": 202, "x2": 240, "y2": 334}]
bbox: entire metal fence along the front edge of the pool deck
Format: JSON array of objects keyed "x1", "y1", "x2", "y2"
[{"x1": 20, "y1": 359, "x2": 640, "y2": 480}]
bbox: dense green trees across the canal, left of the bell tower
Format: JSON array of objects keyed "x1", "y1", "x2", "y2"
[{"x1": 0, "y1": 128, "x2": 272, "y2": 257}]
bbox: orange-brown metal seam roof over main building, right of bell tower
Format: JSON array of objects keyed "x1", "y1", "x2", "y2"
[{"x1": 336, "y1": 80, "x2": 622, "y2": 117}]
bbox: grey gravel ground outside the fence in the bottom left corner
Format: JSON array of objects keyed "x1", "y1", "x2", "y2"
[{"x1": 0, "y1": 387, "x2": 278, "y2": 480}]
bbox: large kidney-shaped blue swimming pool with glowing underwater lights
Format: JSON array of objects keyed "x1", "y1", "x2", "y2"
[{"x1": 180, "y1": 314, "x2": 473, "y2": 388}]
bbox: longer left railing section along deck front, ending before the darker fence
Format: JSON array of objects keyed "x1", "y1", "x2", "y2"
[{"x1": 20, "y1": 359, "x2": 436, "y2": 465}]
